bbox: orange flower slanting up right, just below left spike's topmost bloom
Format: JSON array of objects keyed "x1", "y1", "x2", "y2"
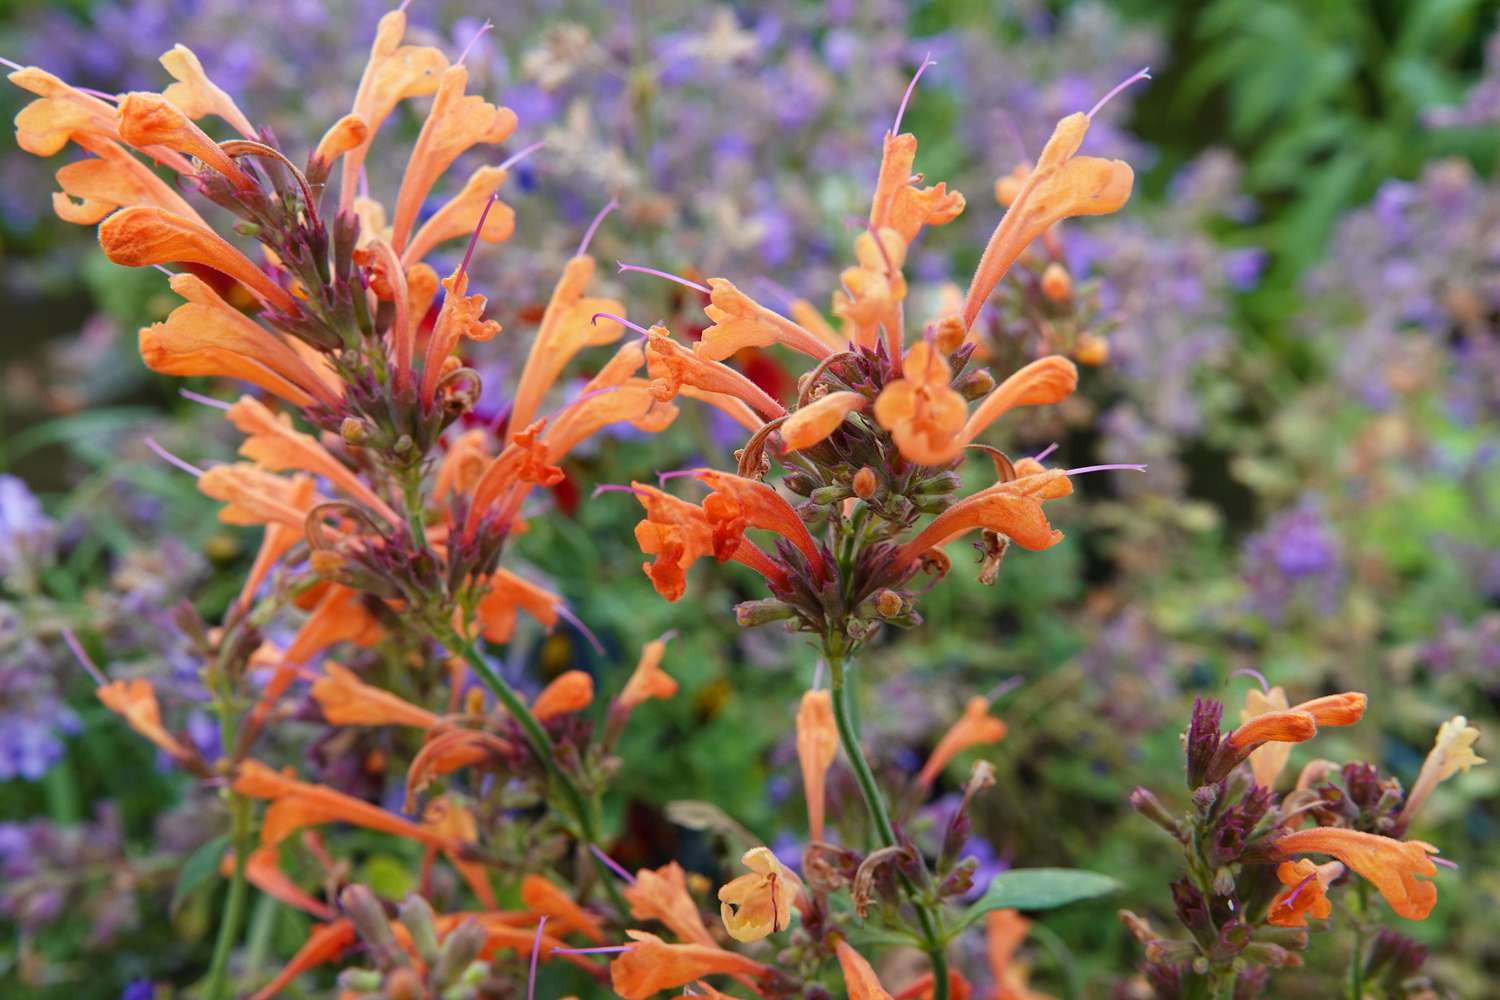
[{"x1": 390, "y1": 64, "x2": 516, "y2": 253}]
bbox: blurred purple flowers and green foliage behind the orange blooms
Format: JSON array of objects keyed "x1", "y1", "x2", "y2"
[{"x1": 0, "y1": 0, "x2": 1500, "y2": 997}]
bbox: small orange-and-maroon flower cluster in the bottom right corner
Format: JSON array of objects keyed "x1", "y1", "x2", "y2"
[{"x1": 1121, "y1": 687, "x2": 1484, "y2": 1000}]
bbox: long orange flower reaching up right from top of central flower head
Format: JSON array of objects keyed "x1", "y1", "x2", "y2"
[{"x1": 963, "y1": 112, "x2": 1136, "y2": 330}]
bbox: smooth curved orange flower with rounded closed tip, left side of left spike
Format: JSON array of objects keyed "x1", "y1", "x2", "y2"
[{"x1": 99, "y1": 205, "x2": 297, "y2": 315}]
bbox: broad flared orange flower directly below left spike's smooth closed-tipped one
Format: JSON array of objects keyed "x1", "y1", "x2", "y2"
[{"x1": 141, "y1": 274, "x2": 341, "y2": 408}]
